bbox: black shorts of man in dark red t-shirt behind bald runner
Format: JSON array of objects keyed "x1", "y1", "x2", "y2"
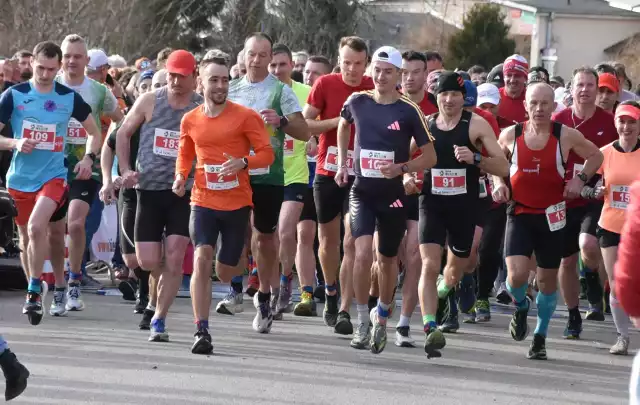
[{"x1": 562, "y1": 202, "x2": 604, "y2": 258}]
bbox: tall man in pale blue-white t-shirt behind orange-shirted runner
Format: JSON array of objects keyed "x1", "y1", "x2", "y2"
[{"x1": 221, "y1": 33, "x2": 309, "y2": 333}]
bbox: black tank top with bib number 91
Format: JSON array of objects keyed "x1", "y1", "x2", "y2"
[{"x1": 422, "y1": 111, "x2": 480, "y2": 203}]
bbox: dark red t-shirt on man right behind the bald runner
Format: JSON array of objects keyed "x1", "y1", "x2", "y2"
[{"x1": 551, "y1": 107, "x2": 618, "y2": 207}]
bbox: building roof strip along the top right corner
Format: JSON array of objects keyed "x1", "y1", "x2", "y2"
[{"x1": 498, "y1": 0, "x2": 640, "y2": 19}]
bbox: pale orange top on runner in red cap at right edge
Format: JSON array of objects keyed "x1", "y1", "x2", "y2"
[{"x1": 598, "y1": 141, "x2": 640, "y2": 233}]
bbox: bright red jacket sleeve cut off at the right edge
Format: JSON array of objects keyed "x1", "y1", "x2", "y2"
[{"x1": 614, "y1": 180, "x2": 640, "y2": 317}]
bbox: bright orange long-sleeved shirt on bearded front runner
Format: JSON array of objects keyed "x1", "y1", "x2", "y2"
[{"x1": 176, "y1": 101, "x2": 274, "y2": 211}]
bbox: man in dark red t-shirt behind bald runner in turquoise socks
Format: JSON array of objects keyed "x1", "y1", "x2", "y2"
[{"x1": 553, "y1": 67, "x2": 618, "y2": 339}]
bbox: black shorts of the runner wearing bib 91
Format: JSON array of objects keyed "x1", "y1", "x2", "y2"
[{"x1": 418, "y1": 194, "x2": 477, "y2": 259}]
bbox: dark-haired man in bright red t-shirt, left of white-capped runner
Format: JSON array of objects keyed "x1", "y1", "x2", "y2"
[{"x1": 303, "y1": 37, "x2": 373, "y2": 335}]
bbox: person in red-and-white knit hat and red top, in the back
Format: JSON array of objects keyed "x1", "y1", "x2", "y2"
[{"x1": 497, "y1": 55, "x2": 529, "y2": 129}]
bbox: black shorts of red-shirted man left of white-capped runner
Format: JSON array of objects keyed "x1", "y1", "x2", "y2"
[{"x1": 313, "y1": 174, "x2": 353, "y2": 224}]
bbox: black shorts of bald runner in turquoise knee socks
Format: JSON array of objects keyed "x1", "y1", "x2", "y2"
[{"x1": 504, "y1": 214, "x2": 566, "y2": 269}]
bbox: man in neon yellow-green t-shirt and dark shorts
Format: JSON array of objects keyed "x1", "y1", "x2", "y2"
[{"x1": 269, "y1": 44, "x2": 315, "y2": 319}]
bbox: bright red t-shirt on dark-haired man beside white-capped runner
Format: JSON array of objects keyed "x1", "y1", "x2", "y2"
[{"x1": 307, "y1": 73, "x2": 374, "y2": 176}]
